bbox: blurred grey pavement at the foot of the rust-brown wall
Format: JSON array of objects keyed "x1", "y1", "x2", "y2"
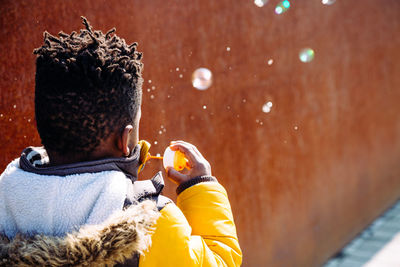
[{"x1": 323, "y1": 200, "x2": 400, "y2": 267}]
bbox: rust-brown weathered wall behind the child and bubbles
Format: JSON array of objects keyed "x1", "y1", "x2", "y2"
[{"x1": 0, "y1": 0, "x2": 400, "y2": 266}]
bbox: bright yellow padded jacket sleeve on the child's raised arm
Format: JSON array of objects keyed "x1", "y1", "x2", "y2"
[{"x1": 139, "y1": 182, "x2": 242, "y2": 267}]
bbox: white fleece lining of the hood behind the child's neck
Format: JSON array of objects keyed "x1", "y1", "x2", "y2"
[{"x1": 0, "y1": 159, "x2": 131, "y2": 241}]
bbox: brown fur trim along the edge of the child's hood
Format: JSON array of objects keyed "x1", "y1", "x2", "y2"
[{"x1": 0, "y1": 201, "x2": 159, "y2": 266}]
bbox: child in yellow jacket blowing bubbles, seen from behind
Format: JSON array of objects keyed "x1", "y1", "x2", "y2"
[{"x1": 0, "y1": 17, "x2": 242, "y2": 267}]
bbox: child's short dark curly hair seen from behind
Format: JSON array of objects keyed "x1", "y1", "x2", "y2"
[{"x1": 33, "y1": 17, "x2": 143, "y2": 155}]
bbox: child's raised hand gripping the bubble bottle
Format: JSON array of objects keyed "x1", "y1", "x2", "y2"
[{"x1": 167, "y1": 141, "x2": 211, "y2": 185}]
